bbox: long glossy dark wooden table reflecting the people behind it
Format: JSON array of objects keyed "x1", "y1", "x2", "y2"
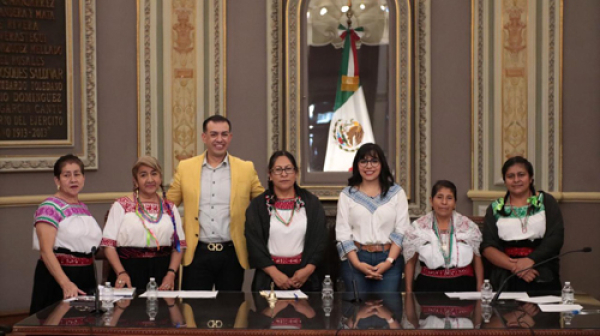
[{"x1": 13, "y1": 292, "x2": 600, "y2": 335}]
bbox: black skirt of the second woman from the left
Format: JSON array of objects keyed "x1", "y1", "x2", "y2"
[{"x1": 108, "y1": 255, "x2": 171, "y2": 295}]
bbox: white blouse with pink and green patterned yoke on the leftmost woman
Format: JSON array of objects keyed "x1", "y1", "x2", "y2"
[{"x1": 33, "y1": 197, "x2": 102, "y2": 253}]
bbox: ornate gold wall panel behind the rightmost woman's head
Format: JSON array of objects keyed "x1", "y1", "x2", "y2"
[{"x1": 469, "y1": 0, "x2": 562, "y2": 213}]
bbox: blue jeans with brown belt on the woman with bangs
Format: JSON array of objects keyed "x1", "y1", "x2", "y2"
[{"x1": 342, "y1": 251, "x2": 404, "y2": 293}]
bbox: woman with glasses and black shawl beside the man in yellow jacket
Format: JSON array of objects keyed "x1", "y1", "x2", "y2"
[{"x1": 245, "y1": 151, "x2": 328, "y2": 292}]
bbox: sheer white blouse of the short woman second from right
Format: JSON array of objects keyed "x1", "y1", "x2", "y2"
[{"x1": 403, "y1": 211, "x2": 482, "y2": 269}]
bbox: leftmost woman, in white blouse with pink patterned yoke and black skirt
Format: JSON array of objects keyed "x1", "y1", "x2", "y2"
[{"x1": 29, "y1": 154, "x2": 102, "y2": 314}]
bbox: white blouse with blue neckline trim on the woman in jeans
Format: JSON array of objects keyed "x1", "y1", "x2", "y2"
[{"x1": 335, "y1": 184, "x2": 410, "y2": 260}]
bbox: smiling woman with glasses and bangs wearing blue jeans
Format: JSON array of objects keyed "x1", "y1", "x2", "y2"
[{"x1": 335, "y1": 143, "x2": 410, "y2": 293}]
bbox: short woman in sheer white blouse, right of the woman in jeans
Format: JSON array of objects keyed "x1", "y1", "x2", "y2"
[{"x1": 403, "y1": 180, "x2": 483, "y2": 293}]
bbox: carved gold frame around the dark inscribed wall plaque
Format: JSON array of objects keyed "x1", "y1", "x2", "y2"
[{"x1": 0, "y1": 0, "x2": 98, "y2": 172}]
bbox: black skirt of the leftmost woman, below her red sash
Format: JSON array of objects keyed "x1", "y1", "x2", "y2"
[{"x1": 29, "y1": 259, "x2": 96, "y2": 315}]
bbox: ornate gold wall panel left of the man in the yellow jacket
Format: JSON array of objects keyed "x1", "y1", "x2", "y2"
[{"x1": 137, "y1": 0, "x2": 226, "y2": 181}]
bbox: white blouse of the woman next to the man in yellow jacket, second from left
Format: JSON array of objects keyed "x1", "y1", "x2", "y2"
[{"x1": 100, "y1": 197, "x2": 186, "y2": 248}]
